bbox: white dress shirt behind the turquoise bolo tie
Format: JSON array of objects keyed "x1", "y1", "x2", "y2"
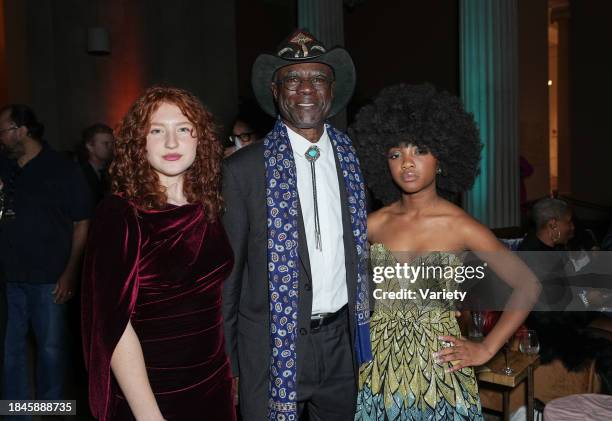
[{"x1": 287, "y1": 123, "x2": 348, "y2": 314}]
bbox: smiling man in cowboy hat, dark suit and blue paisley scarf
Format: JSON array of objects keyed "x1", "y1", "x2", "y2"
[{"x1": 223, "y1": 30, "x2": 370, "y2": 421}]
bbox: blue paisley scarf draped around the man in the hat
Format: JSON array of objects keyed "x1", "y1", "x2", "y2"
[{"x1": 264, "y1": 118, "x2": 372, "y2": 421}]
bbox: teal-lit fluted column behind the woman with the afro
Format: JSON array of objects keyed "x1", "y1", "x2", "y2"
[{"x1": 460, "y1": 0, "x2": 520, "y2": 228}]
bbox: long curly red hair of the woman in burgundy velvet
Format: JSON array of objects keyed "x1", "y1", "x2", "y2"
[{"x1": 109, "y1": 86, "x2": 223, "y2": 220}]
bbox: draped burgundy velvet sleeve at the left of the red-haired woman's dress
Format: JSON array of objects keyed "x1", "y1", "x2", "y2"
[{"x1": 81, "y1": 196, "x2": 140, "y2": 421}]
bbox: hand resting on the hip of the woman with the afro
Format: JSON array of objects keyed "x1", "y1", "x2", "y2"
[{"x1": 433, "y1": 336, "x2": 495, "y2": 373}]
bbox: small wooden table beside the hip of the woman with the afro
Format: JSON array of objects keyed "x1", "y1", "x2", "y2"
[{"x1": 476, "y1": 351, "x2": 540, "y2": 421}]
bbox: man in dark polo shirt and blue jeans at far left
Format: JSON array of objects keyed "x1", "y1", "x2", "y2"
[{"x1": 0, "y1": 104, "x2": 91, "y2": 412}]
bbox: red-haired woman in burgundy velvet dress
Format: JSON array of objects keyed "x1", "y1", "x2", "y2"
[{"x1": 82, "y1": 87, "x2": 235, "y2": 420}]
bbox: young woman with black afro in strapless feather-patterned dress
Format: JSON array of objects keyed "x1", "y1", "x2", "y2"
[{"x1": 349, "y1": 84, "x2": 539, "y2": 421}]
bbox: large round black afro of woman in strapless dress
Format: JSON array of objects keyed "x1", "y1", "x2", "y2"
[{"x1": 349, "y1": 84, "x2": 482, "y2": 205}]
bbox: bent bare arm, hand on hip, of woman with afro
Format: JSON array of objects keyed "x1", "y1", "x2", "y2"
[{"x1": 435, "y1": 218, "x2": 541, "y2": 371}]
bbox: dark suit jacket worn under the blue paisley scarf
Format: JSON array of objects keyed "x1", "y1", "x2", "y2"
[{"x1": 223, "y1": 139, "x2": 357, "y2": 402}]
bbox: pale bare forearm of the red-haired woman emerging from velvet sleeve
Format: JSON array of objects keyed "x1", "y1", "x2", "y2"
[{"x1": 111, "y1": 322, "x2": 164, "y2": 421}]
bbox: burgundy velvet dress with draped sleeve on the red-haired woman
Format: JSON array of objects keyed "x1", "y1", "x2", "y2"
[{"x1": 82, "y1": 196, "x2": 235, "y2": 421}]
